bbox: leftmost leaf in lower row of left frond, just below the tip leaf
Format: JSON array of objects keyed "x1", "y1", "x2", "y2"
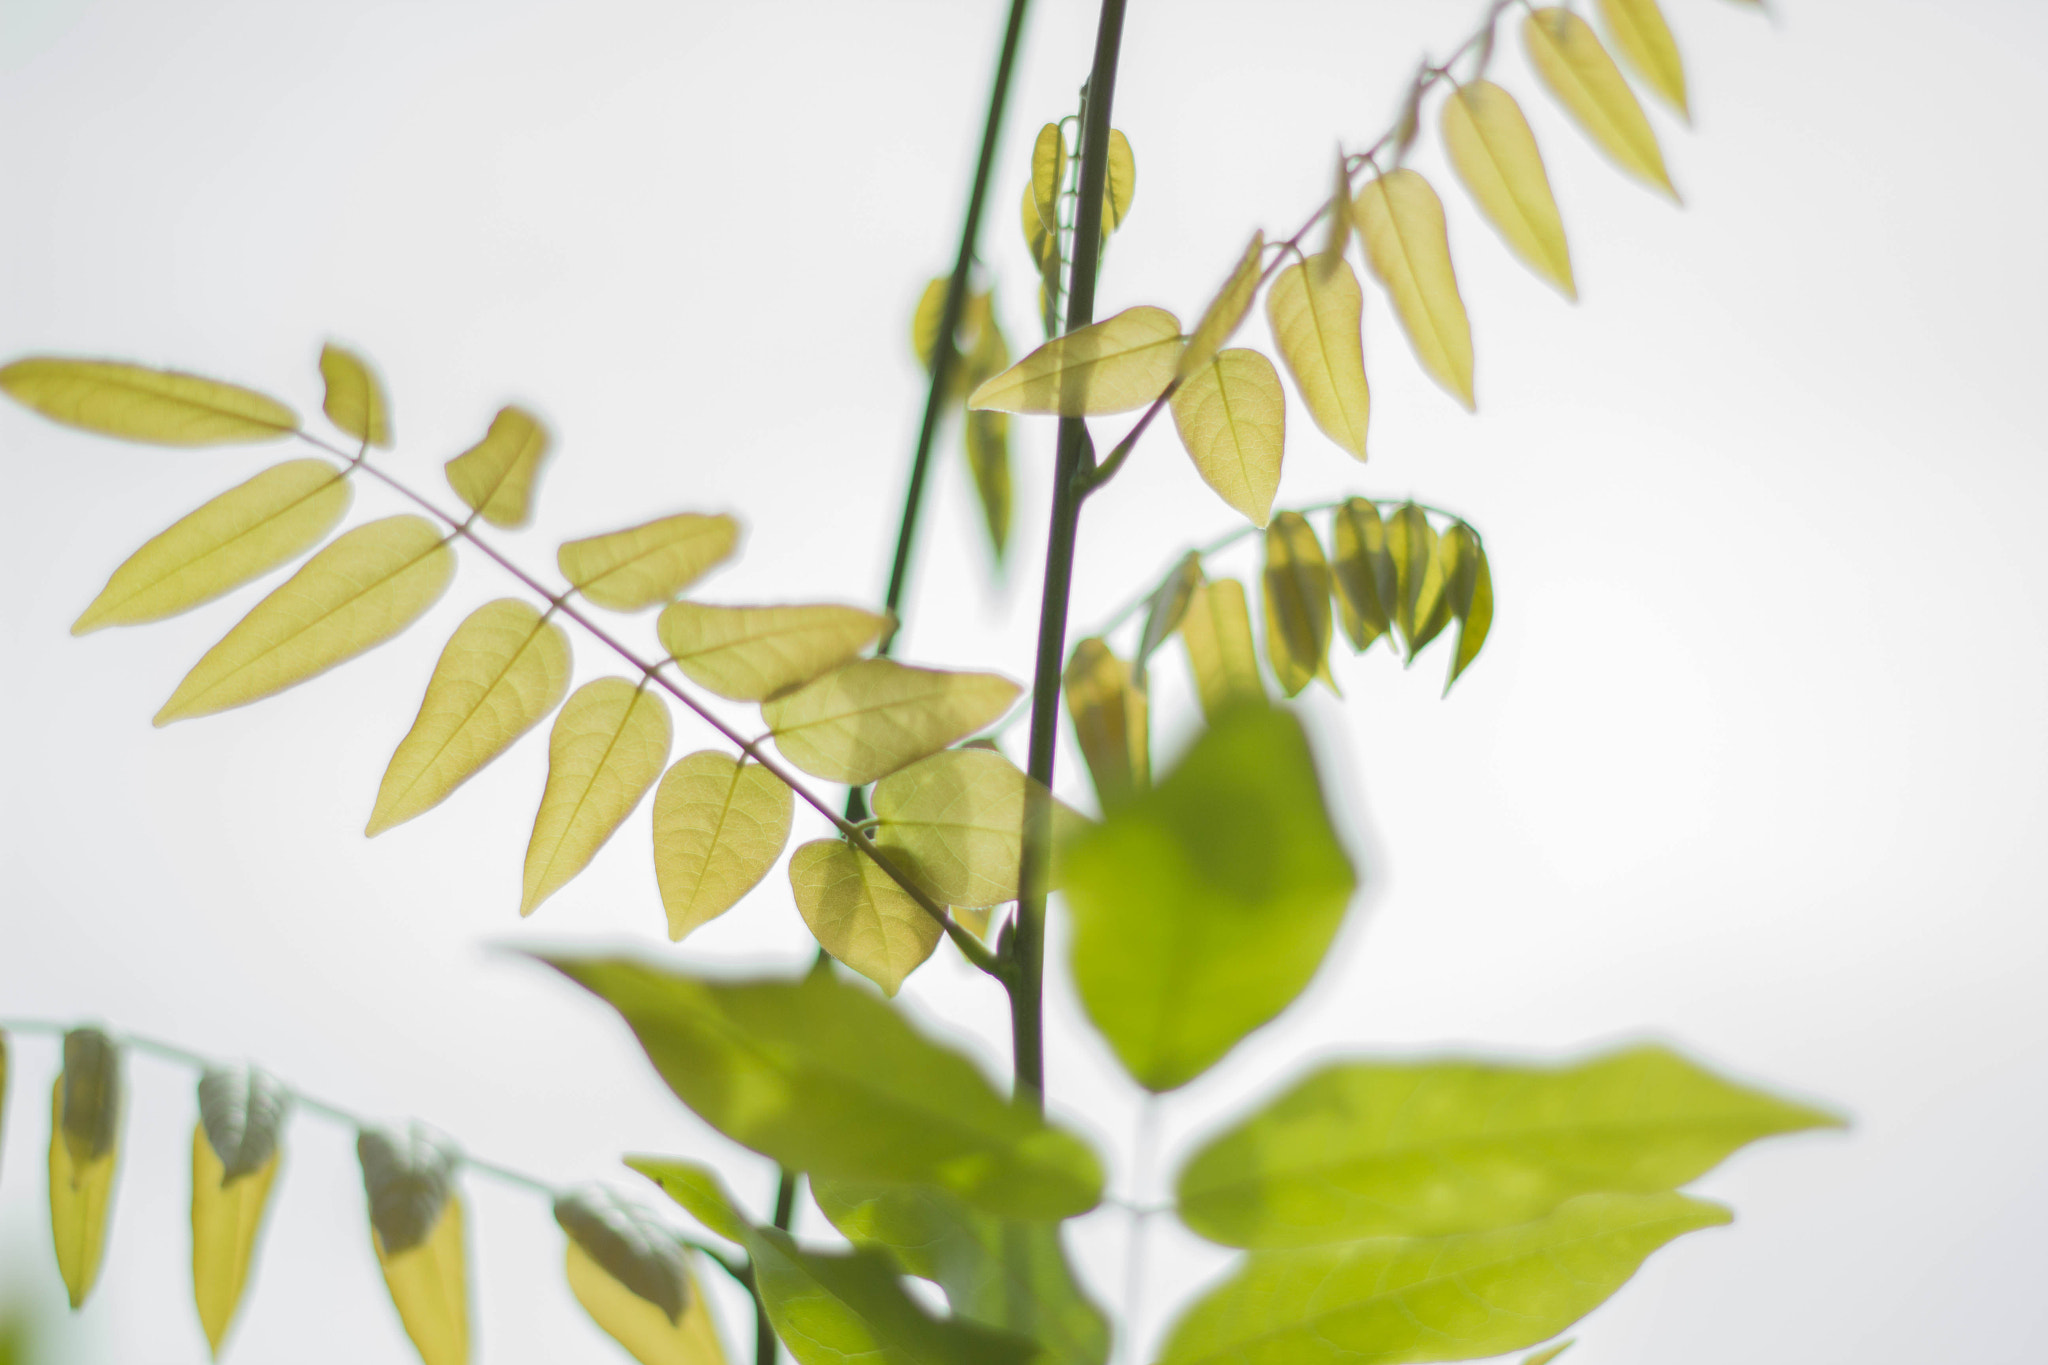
[{"x1": 72, "y1": 460, "x2": 350, "y2": 634}]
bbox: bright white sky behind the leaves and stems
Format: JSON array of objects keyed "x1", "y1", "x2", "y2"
[{"x1": 0, "y1": 0, "x2": 2048, "y2": 1365}]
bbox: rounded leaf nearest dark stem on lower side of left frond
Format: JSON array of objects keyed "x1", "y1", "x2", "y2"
[{"x1": 788, "y1": 839, "x2": 944, "y2": 997}]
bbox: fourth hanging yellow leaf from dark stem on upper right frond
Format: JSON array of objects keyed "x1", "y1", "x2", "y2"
[{"x1": 1444, "y1": 80, "x2": 1579, "y2": 299}]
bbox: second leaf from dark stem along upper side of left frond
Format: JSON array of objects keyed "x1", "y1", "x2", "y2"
[{"x1": 762, "y1": 659, "x2": 1022, "y2": 786}]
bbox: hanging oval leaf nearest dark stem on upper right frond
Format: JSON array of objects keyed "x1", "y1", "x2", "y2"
[{"x1": 1174, "y1": 348, "x2": 1286, "y2": 526}]
